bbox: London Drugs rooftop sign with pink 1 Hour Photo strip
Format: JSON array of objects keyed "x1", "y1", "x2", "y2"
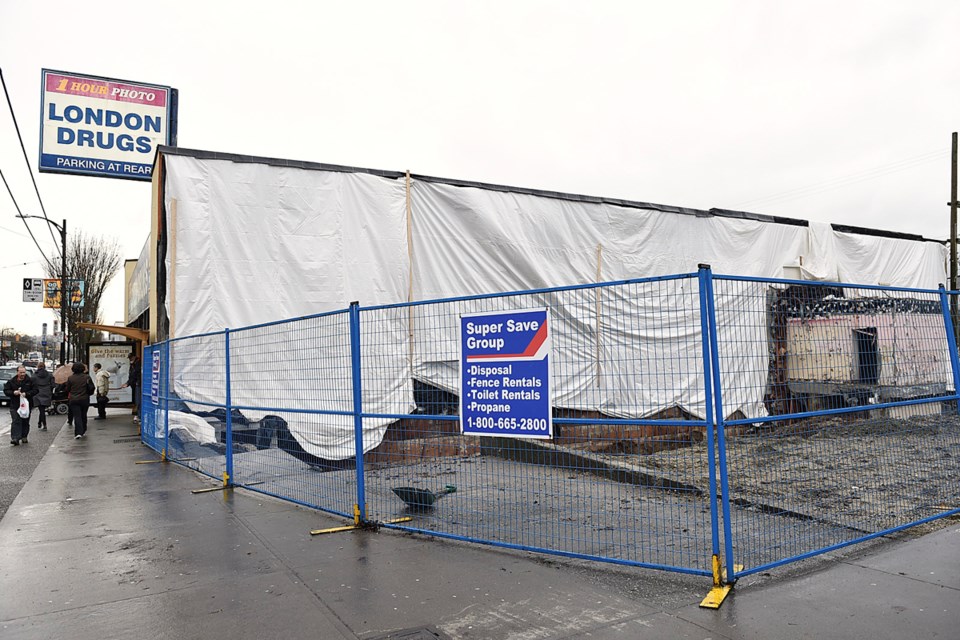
[{"x1": 40, "y1": 69, "x2": 177, "y2": 180}]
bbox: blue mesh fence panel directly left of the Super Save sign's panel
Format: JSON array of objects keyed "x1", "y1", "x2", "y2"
[{"x1": 230, "y1": 312, "x2": 357, "y2": 515}]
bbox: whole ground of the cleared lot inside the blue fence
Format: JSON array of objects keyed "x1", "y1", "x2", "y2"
[{"x1": 167, "y1": 416, "x2": 960, "y2": 571}]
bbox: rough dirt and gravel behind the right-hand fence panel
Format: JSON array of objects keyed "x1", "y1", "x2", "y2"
[{"x1": 642, "y1": 416, "x2": 960, "y2": 532}]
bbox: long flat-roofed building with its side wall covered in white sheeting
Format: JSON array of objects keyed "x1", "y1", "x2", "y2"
[{"x1": 128, "y1": 147, "x2": 947, "y2": 459}]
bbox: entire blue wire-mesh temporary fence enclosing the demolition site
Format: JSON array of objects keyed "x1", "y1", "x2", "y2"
[{"x1": 142, "y1": 269, "x2": 960, "y2": 577}]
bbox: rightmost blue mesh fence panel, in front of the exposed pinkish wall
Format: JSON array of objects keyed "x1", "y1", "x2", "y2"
[{"x1": 714, "y1": 278, "x2": 960, "y2": 570}]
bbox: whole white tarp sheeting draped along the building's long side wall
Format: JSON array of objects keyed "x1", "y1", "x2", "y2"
[{"x1": 165, "y1": 155, "x2": 946, "y2": 459}]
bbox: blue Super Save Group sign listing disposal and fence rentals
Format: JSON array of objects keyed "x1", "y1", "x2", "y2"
[{"x1": 460, "y1": 309, "x2": 553, "y2": 438}]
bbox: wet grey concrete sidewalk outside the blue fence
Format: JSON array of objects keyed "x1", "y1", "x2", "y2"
[{"x1": 0, "y1": 415, "x2": 960, "y2": 640}]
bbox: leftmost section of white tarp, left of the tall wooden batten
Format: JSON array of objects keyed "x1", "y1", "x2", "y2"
[{"x1": 165, "y1": 156, "x2": 414, "y2": 459}]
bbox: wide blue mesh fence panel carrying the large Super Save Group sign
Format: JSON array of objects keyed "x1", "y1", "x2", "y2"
[{"x1": 360, "y1": 278, "x2": 711, "y2": 572}]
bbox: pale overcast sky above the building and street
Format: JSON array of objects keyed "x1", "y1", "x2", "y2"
[{"x1": 0, "y1": 0, "x2": 960, "y2": 334}]
